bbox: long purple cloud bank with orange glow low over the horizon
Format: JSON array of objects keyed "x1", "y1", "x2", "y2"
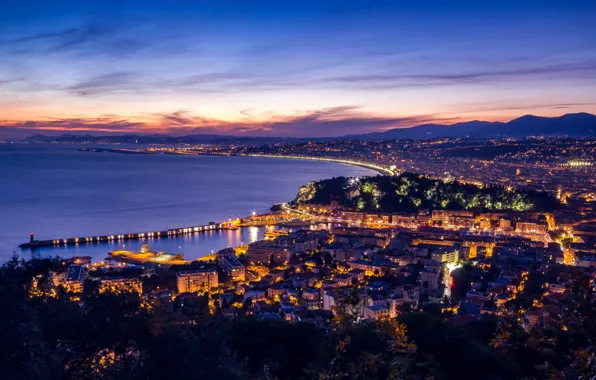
[{"x1": 0, "y1": 106, "x2": 456, "y2": 137}]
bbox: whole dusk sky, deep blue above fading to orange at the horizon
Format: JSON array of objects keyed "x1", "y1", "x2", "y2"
[{"x1": 0, "y1": 0, "x2": 596, "y2": 138}]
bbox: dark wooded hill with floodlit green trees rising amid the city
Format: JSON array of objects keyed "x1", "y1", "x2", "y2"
[{"x1": 294, "y1": 173, "x2": 559, "y2": 212}]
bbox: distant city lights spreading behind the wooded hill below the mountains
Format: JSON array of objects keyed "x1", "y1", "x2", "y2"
[{"x1": 115, "y1": 137, "x2": 596, "y2": 199}]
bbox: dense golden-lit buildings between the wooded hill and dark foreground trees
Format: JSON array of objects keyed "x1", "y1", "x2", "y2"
[{"x1": 42, "y1": 205, "x2": 596, "y2": 320}]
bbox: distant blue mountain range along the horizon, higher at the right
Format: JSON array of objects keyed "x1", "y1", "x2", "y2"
[{"x1": 12, "y1": 113, "x2": 596, "y2": 145}]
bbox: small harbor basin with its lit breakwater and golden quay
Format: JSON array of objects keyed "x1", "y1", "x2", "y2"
[{"x1": 20, "y1": 211, "x2": 330, "y2": 265}]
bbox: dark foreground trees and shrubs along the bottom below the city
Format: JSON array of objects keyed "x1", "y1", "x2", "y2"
[{"x1": 0, "y1": 259, "x2": 596, "y2": 380}]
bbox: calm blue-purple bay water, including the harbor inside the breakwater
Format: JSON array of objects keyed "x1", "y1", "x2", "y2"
[{"x1": 0, "y1": 144, "x2": 375, "y2": 262}]
